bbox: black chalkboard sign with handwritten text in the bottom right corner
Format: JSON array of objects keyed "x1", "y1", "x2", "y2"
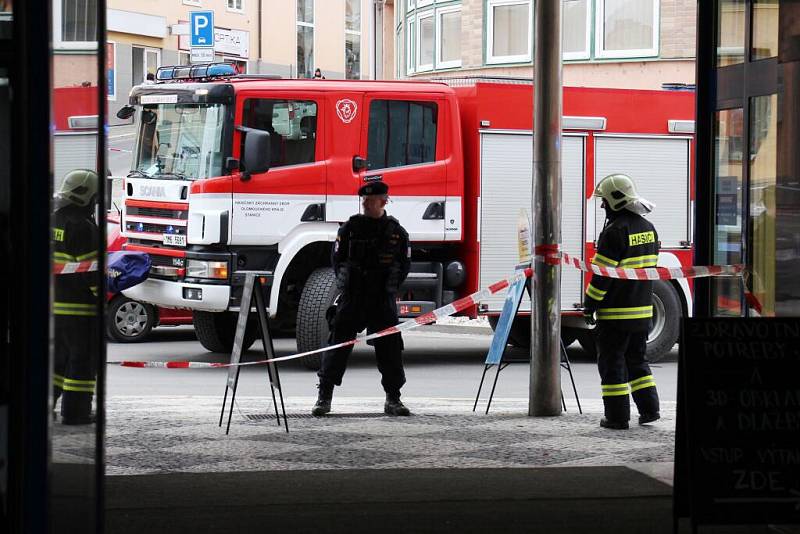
[{"x1": 676, "y1": 318, "x2": 800, "y2": 524}]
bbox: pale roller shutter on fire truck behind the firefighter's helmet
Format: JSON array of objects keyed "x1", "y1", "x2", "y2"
[{"x1": 594, "y1": 136, "x2": 690, "y2": 248}]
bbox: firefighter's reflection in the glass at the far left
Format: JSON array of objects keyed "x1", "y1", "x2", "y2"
[{"x1": 52, "y1": 169, "x2": 99, "y2": 425}]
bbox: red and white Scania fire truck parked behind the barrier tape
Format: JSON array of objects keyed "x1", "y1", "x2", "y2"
[{"x1": 120, "y1": 64, "x2": 694, "y2": 367}]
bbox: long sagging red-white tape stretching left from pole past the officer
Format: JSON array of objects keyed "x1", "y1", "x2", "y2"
[{"x1": 119, "y1": 267, "x2": 533, "y2": 369}]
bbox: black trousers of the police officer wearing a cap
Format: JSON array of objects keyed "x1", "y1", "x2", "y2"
[{"x1": 317, "y1": 293, "x2": 406, "y2": 398}]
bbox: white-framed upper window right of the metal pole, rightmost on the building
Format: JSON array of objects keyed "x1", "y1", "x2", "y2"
[{"x1": 595, "y1": 0, "x2": 659, "y2": 58}]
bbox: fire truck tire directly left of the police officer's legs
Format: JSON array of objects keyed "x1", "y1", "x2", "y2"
[{"x1": 296, "y1": 267, "x2": 338, "y2": 371}]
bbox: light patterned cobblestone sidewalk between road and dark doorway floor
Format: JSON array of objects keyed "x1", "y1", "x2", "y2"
[{"x1": 100, "y1": 395, "x2": 675, "y2": 484}]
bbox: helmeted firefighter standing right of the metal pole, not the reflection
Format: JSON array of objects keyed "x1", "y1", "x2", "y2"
[{"x1": 584, "y1": 174, "x2": 660, "y2": 430}]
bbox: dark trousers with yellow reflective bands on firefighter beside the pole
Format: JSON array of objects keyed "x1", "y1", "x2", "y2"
[{"x1": 595, "y1": 321, "x2": 659, "y2": 421}]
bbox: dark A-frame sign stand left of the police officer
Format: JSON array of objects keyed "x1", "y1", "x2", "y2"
[{"x1": 219, "y1": 271, "x2": 289, "y2": 434}]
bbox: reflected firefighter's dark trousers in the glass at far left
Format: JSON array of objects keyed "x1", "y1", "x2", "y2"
[{"x1": 53, "y1": 315, "x2": 100, "y2": 418}]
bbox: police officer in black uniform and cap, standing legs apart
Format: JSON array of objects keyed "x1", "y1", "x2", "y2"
[{"x1": 311, "y1": 182, "x2": 411, "y2": 416}]
